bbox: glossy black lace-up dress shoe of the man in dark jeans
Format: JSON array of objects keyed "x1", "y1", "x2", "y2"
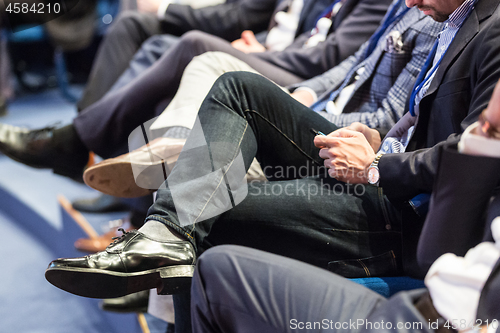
[{"x1": 45, "y1": 230, "x2": 196, "y2": 298}]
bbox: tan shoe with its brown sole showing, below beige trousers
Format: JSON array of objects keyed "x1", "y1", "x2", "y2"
[{"x1": 83, "y1": 138, "x2": 186, "y2": 198}]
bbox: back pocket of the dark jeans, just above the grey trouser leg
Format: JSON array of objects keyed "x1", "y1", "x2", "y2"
[{"x1": 327, "y1": 250, "x2": 401, "y2": 278}]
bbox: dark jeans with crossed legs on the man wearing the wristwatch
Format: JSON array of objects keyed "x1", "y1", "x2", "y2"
[{"x1": 147, "y1": 72, "x2": 401, "y2": 277}]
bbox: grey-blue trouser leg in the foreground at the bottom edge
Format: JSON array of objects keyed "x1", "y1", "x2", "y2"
[{"x1": 191, "y1": 245, "x2": 433, "y2": 333}]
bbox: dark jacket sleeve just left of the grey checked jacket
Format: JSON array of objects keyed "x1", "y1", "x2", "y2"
[{"x1": 256, "y1": 0, "x2": 392, "y2": 79}]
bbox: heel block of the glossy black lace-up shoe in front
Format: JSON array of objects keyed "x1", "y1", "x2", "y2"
[{"x1": 156, "y1": 265, "x2": 195, "y2": 295}]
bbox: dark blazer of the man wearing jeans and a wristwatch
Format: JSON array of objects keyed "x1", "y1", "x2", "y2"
[{"x1": 379, "y1": 0, "x2": 500, "y2": 204}]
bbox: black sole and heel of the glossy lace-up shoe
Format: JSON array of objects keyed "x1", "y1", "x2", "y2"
[{"x1": 45, "y1": 265, "x2": 194, "y2": 298}]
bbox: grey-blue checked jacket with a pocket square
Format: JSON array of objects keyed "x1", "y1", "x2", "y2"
[{"x1": 292, "y1": 0, "x2": 442, "y2": 129}]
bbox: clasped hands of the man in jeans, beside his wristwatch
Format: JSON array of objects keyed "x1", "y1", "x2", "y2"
[{"x1": 314, "y1": 128, "x2": 376, "y2": 184}]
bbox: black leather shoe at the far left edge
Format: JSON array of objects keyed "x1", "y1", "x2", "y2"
[{"x1": 0, "y1": 123, "x2": 89, "y2": 181}]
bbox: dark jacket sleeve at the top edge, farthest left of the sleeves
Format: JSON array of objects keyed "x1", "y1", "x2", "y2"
[{"x1": 161, "y1": 0, "x2": 277, "y2": 41}]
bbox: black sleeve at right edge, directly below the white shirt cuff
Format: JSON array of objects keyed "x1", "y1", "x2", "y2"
[{"x1": 417, "y1": 145, "x2": 500, "y2": 271}]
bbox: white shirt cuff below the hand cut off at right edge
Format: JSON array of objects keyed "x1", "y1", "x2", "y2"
[{"x1": 458, "y1": 122, "x2": 500, "y2": 157}]
